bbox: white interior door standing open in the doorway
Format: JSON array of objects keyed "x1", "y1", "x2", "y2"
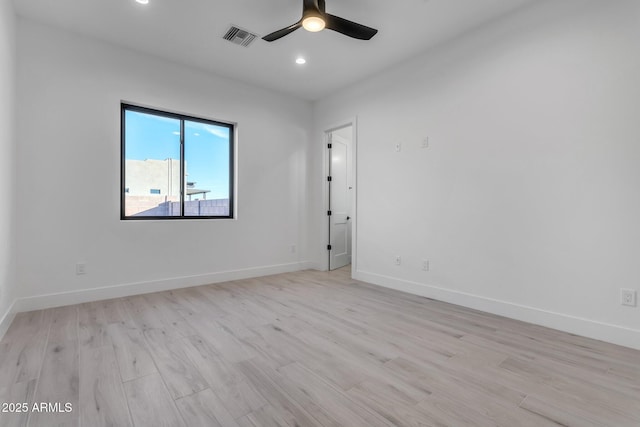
[{"x1": 329, "y1": 126, "x2": 353, "y2": 270}]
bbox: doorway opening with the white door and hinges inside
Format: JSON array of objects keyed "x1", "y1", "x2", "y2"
[{"x1": 325, "y1": 122, "x2": 356, "y2": 271}]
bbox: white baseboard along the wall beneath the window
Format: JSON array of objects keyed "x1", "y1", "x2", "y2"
[{"x1": 9, "y1": 261, "x2": 311, "y2": 314}]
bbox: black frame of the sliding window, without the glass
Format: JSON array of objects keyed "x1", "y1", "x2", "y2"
[{"x1": 120, "y1": 102, "x2": 236, "y2": 221}]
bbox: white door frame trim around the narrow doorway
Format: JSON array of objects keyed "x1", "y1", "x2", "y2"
[{"x1": 321, "y1": 117, "x2": 358, "y2": 270}]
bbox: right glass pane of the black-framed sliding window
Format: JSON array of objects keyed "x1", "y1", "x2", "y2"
[{"x1": 184, "y1": 120, "x2": 231, "y2": 216}]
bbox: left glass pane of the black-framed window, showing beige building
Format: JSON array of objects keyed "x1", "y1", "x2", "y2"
[{"x1": 124, "y1": 110, "x2": 180, "y2": 216}]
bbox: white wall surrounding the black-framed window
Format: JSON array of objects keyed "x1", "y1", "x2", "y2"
[{"x1": 17, "y1": 20, "x2": 312, "y2": 310}]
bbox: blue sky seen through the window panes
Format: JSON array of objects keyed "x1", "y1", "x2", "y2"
[{"x1": 125, "y1": 111, "x2": 229, "y2": 199}]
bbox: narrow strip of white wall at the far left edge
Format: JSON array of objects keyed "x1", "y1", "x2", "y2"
[{"x1": 0, "y1": 0, "x2": 16, "y2": 336}]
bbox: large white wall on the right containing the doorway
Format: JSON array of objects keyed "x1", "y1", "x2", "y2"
[{"x1": 312, "y1": 0, "x2": 640, "y2": 348}]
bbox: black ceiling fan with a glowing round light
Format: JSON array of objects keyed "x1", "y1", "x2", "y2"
[{"x1": 262, "y1": 0, "x2": 378, "y2": 42}]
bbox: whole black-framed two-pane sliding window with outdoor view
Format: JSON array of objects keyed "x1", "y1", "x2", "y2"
[{"x1": 120, "y1": 104, "x2": 234, "y2": 219}]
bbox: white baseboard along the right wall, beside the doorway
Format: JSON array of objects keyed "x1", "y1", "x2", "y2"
[{"x1": 353, "y1": 270, "x2": 640, "y2": 350}]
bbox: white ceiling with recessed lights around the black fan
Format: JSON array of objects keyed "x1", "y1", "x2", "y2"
[{"x1": 14, "y1": 0, "x2": 532, "y2": 100}]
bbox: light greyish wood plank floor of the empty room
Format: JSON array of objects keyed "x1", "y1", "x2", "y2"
[{"x1": 0, "y1": 270, "x2": 640, "y2": 427}]
